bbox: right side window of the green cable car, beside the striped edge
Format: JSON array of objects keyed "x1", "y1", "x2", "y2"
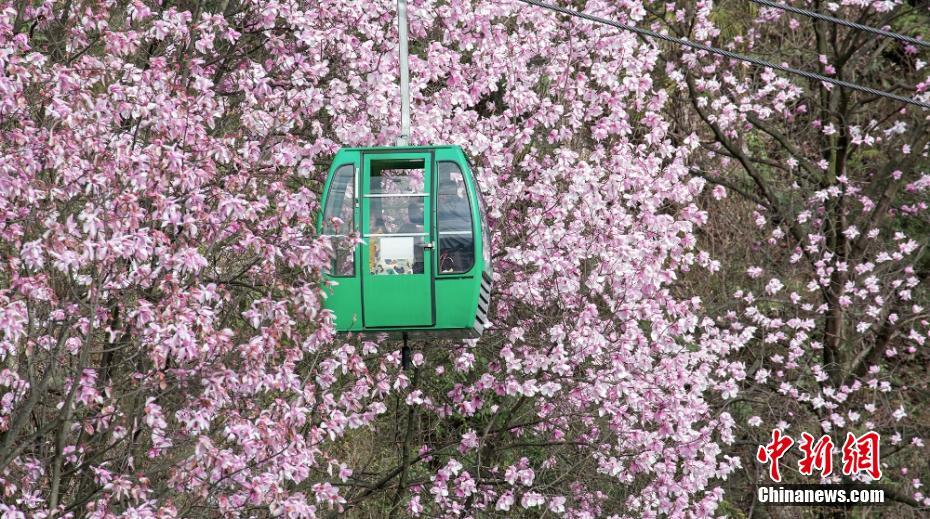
[{"x1": 436, "y1": 162, "x2": 475, "y2": 274}]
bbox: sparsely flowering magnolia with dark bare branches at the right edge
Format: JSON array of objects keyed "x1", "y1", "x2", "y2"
[{"x1": 654, "y1": 1, "x2": 930, "y2": 516}]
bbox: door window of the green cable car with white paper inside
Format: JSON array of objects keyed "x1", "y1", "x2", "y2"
[{"x1": 365, "y1": 160, "x2": 429, "y2": 275}]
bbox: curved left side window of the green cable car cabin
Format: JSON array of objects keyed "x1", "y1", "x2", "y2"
[{"x1": 323, "y1": 164, "x2": 355, "y2": 276}]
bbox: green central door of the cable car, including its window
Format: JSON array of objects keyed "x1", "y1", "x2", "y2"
[{"x1": 360, "y1": 152, "x2": 435, "y2": 328}]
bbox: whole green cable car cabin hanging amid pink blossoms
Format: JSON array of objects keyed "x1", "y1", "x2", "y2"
[{"x1": 318, "y1": 146, "x2": 491, "y2": 338}]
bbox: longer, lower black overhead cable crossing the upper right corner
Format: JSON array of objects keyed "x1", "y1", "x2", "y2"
[{"x1": 518, "y1": 0, "x2": 930, "y2": 109}]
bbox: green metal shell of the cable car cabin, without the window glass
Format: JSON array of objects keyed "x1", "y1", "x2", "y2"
[{"x1": 319, "y1": 146, "x2": 492, "y2": 337}]
